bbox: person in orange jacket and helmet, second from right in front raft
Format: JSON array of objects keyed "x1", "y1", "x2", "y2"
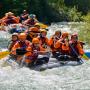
[{"x1": 55, "y1": 32, "x2": 70, "y2": 60}]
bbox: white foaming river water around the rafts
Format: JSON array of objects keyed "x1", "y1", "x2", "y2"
[{"x1": 0, "y1": 23, "x2": 90, "y2": 90}]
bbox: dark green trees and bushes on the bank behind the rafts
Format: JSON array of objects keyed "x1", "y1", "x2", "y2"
[{"x1": 0, "y1": 0, "x2": 90, "y2": 23}]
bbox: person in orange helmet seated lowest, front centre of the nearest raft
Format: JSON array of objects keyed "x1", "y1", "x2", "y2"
[{"x1": 25, "y1": 38, "x2": 49, "y2": 66}]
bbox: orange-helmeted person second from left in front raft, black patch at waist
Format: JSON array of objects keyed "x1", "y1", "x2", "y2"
[{"x1": 11, "y1": 33, "x2": 31, "y2": 63}]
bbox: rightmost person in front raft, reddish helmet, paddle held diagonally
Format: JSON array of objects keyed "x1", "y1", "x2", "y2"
[{"x1": 69, "y1": 33, "x2": 84, "y2": 61}]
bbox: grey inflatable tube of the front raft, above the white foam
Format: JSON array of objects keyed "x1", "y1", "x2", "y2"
[{"x1": 30, "y1": 58, "x2": 84, "y2": 71}]
